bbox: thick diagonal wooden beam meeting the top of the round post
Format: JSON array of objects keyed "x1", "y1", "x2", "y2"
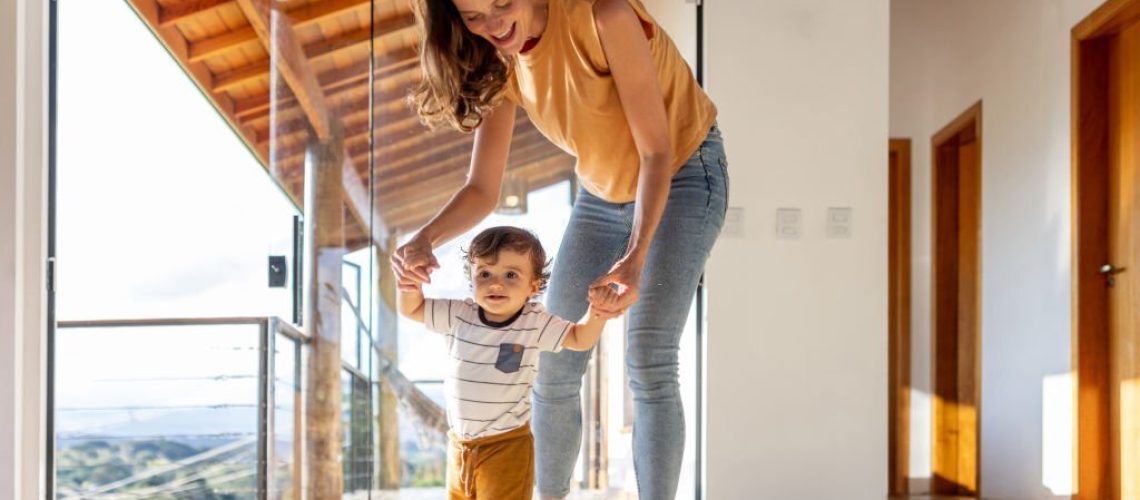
[{"x1": 237, "y1": 0, "x2": 332, "y2": 141}]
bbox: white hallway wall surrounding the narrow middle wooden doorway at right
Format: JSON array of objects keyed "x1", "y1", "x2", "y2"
[{"x1": 890, "y1": 0, "x2": 1100, "y2": 499}]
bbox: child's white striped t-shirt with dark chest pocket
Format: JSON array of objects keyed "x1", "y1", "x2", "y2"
[{"x1": 424, "y1": 298, "x2": 573, "y2": 440}]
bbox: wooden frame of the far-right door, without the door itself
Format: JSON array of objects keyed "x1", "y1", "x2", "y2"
[{"x1": 1070, "y1": 0, "x2": 1140, "y2": 499}]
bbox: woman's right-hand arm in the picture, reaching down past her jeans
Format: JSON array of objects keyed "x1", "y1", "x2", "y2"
[{"x1": 594, "y1": 0, "x2": 673, "y2": 312}]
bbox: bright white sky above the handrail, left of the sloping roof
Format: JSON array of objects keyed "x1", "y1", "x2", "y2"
[{"x1": 57, "y1": 0, "x2": 299, "y2": 320}]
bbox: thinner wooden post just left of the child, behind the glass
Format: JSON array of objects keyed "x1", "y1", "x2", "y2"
[{"x1": 373, "y1": 240, "x2": 402, "y2": 490}]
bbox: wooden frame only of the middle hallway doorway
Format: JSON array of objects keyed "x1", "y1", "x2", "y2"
[{"x1": 930, "y1": 100, "x2": 983, "y2": 494}]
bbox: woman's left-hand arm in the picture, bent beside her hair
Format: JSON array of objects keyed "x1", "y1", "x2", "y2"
[{"x1": 392, "y1": 99, "x2": 516, "y2": 287}]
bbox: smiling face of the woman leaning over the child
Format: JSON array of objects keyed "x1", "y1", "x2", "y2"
[{"x1": 451, "y1": 0, "x2": 545, "y2": 55}]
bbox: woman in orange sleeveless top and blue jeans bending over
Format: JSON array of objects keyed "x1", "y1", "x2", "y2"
[{"x1": 392, "y1": 0, "x2": 728, "y2": 500}]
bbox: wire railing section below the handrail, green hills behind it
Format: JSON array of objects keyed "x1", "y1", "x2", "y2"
[{"x1": 55, "y1": 325, "x2": 260, "y2": 498}]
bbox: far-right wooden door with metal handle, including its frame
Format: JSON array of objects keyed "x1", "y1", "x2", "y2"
[{"x1": 1073, "y1": 0, "x2": 1140, "y2": 500}]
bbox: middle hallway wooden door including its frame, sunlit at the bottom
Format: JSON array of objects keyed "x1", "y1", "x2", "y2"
[{"x1": 931, "y1": 103, "x2": 982, "y2": 495}]
